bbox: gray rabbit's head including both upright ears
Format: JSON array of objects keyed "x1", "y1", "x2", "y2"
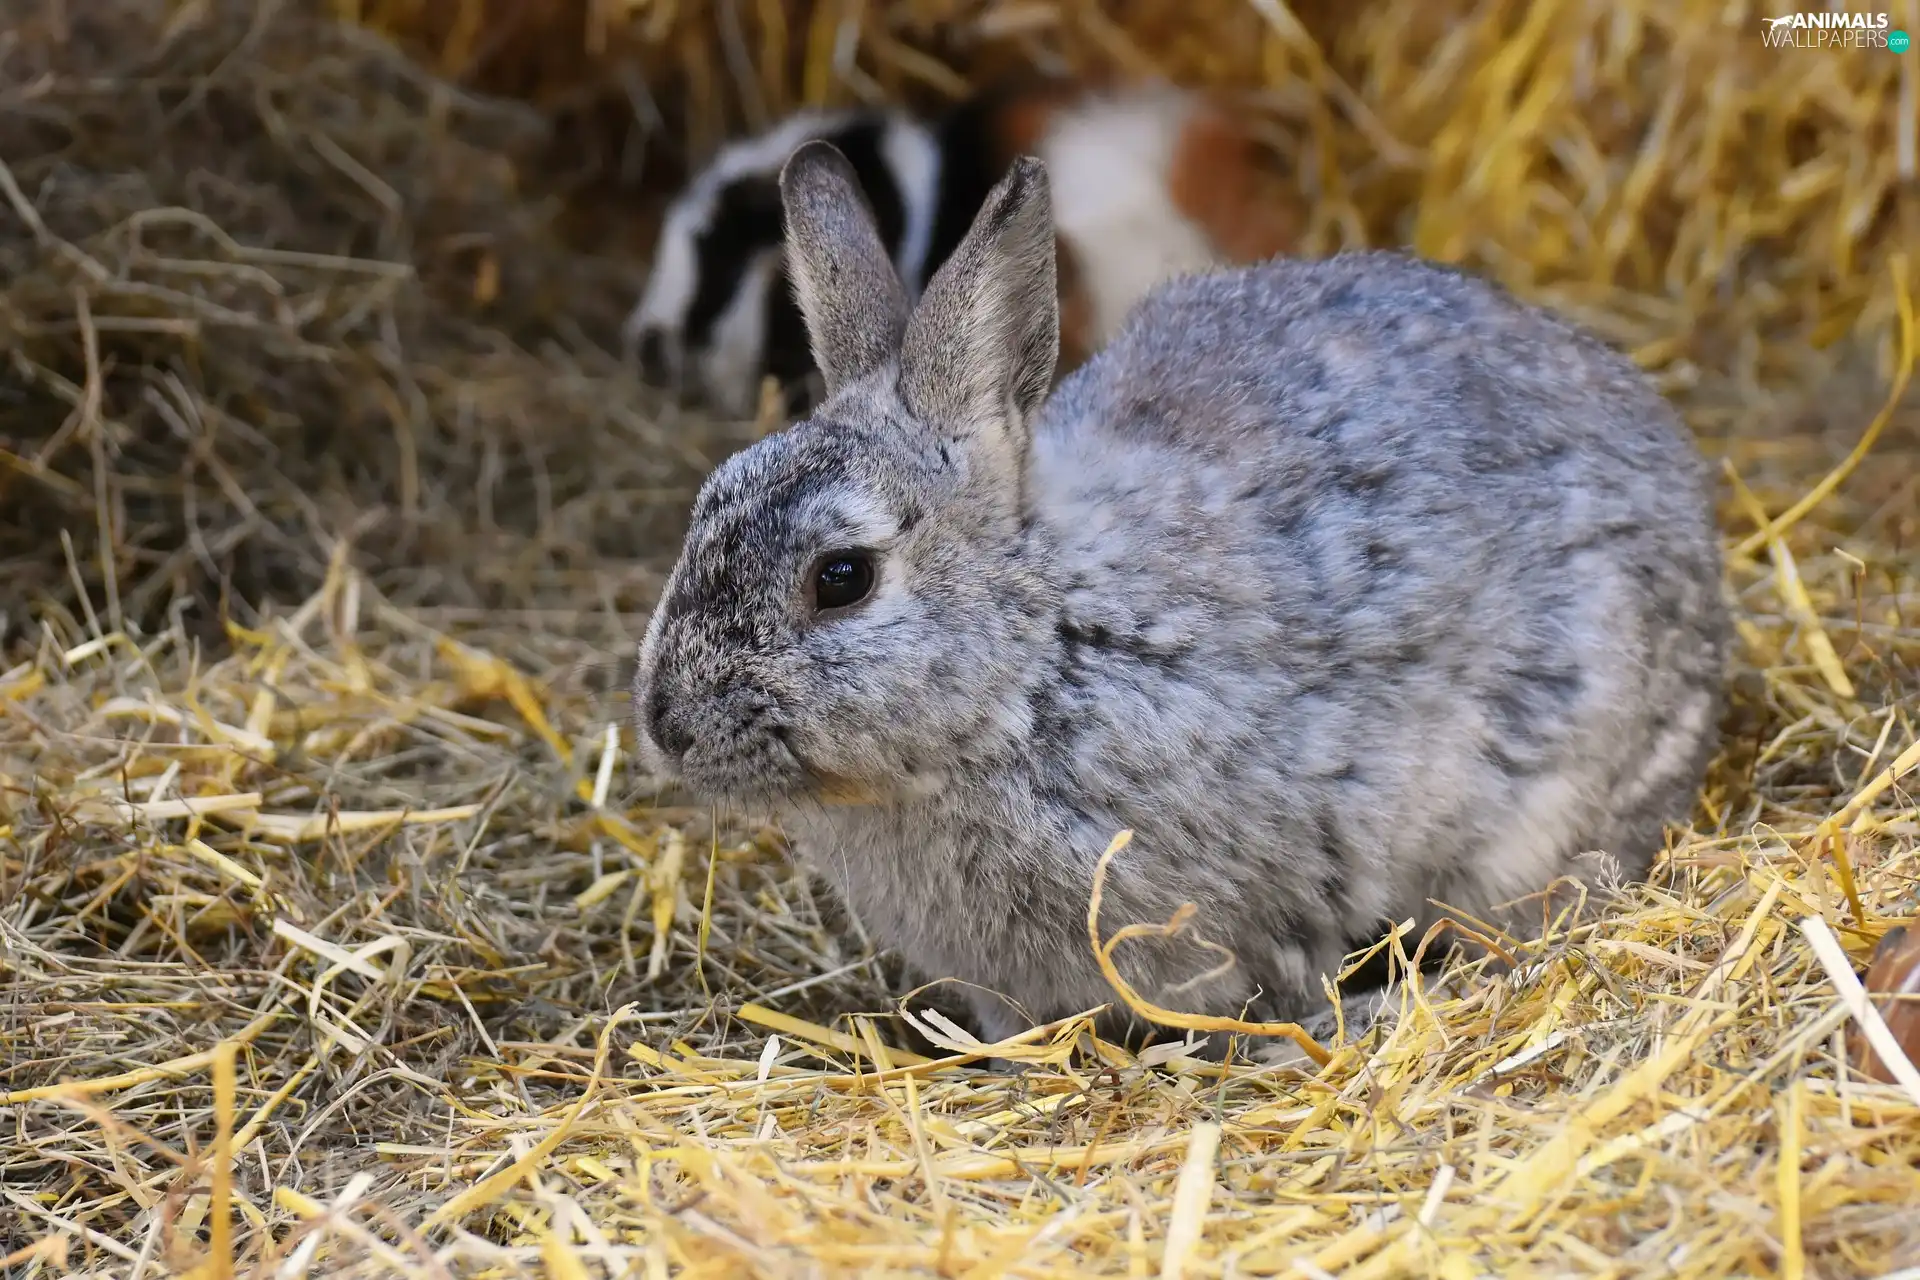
[{"x1": 634, "y1": 142, "x2": 1060, "y2": 804}]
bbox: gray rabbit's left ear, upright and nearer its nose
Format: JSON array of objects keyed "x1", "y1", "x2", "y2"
[{"x1": 780, "y1": 140, "x2": 908, "y2": 395}]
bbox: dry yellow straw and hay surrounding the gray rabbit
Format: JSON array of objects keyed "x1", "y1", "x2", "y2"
[{"x1": 0, "y1": 0, "x2": 1920, "y2": 1280}]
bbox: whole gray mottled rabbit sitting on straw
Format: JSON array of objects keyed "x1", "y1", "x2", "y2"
[{"x1": 634, "y1": 142, "x2": 1728, "y2": 1038}]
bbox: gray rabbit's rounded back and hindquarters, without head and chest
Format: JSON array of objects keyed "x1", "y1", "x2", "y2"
[{"x1": 1033, "y1": 253, "x2": 1726, "y2": 990}]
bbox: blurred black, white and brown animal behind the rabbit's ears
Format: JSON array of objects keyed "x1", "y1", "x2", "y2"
[{"x1": 622, "y1": 79, "x2": 1304, "y2": 416}]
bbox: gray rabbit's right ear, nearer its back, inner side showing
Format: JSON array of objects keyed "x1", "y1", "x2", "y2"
[{"x1": 900, "y1": 155, "x2": 1060, "y2": 474}]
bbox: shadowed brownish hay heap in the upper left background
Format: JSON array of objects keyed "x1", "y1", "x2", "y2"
[{"x1": 0, "y1": 4, "x2": 756, "y2": 637}]
